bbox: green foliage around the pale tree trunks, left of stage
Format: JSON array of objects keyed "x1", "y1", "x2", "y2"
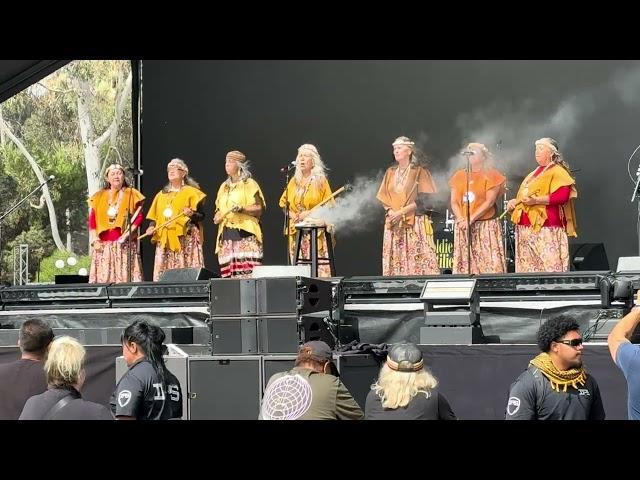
[{"x1": 0, "y1": 60, "x2": 133, "y2": 281}]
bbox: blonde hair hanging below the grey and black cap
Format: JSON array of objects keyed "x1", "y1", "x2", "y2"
[{"x1": 371, "y1": 363, "x2": 438, "y2": 408}]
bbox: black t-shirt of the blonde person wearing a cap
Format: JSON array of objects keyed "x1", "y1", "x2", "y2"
[{"x1": 364, "y1": 390, "x2": 456, "y2": 420}]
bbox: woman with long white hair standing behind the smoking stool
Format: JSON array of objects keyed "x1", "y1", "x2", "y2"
[{"x1": 279, "y1": 143, "x2": 331, "y2": 277}]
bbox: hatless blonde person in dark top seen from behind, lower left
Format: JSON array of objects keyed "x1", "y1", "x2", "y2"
[{"x1": 19, "y1": 336, "x2": 113, "y2": 420}]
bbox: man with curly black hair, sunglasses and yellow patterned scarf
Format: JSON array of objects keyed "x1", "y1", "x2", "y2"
[{"x1": 506, "y1": 315, "x2": 605, "y2": 420}]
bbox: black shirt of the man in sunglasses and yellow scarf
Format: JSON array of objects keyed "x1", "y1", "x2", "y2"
[{"x1": 506, "y1": 365, "x2": 605, "y2": 420}]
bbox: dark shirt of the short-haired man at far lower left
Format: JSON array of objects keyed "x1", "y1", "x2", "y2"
[{"x1": 0, "y1": 359, "x2": 47, "y2": 420}]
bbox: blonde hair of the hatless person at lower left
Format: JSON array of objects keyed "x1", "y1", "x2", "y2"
[{"x1": 44, "y1": 336, "x2": 86, "y2": 388}]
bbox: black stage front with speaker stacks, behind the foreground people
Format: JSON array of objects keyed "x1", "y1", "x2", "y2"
[{"x1": 0, "y1": 272, "x2": 640, "y2": 419}]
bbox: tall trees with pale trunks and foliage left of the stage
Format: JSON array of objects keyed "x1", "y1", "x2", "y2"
[{"x1": 0, "y1": 61, "x2": 133, "y2": 280}]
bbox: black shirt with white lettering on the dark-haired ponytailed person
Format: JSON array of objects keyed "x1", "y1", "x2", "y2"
[{"x1": 110, "y1": 358, "x2": 182, "y2": 420}]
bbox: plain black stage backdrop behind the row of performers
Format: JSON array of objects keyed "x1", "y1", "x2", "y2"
[{"x1": 141, "y1": 60, "x2": 640, "y2": 278}]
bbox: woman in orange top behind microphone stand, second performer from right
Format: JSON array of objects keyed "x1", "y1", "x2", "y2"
[{"x1": 449, "y1": 143, "x2": 506, "y2": 274}]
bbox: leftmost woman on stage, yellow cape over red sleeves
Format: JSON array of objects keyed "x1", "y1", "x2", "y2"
[{"x1": 89, "y1": 163, "x2": 144, "y2": 283}]
